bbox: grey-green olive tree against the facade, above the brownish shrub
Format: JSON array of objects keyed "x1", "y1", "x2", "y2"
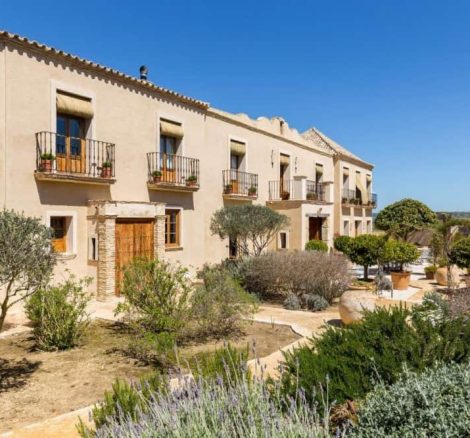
[{"x1": 210, "y1": 204, "x2": 289, "y2": 257}]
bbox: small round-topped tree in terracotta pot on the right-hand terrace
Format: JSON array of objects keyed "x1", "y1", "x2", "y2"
[{"x1": 382, "y1": 239, "x2": 419, "y2": 290}]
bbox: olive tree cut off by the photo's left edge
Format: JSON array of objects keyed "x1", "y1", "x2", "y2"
[{"x1": 0, "y1": 210, "x2": 56, "y2": 331}]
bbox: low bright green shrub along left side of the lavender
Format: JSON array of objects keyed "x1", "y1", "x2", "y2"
[{"x1": 77, "y1": 373, "x2": 168, "y2": 437}]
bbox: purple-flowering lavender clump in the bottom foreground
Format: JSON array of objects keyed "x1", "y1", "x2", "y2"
[{"x1": 90, "y1": 377, "x2": 329, "y2": 438}]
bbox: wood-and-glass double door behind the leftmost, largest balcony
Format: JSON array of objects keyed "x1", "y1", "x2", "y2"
[{"x1": 56, "y1": 114, "x2": 86, "y2": 173}]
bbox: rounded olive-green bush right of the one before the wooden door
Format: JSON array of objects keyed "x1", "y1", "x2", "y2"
[{"x1": 191, "y1": 266, "x2": 257, "y2": 337}]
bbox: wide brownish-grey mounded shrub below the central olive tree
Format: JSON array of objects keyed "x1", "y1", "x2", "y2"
[{"x1": 243, "y1": 251, "x2": 350, "y2": 303}]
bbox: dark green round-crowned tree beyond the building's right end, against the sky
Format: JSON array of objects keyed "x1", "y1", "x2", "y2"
[{"x1": 375, "y1": 199, "x2": 437, "y2": 241}]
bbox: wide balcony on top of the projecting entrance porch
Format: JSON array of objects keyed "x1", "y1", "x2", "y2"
[{"x1": 269, "y1": 178, "x2": 326, "y2": 203}]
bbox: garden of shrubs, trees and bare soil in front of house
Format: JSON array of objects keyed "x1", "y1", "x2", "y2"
[{"x1": 0, "y1": 200, "x2": 470, "y2": 438}]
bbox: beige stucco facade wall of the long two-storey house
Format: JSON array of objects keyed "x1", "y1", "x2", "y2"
[{"x1": 0, "y1": 39, "x2": 374, "y2": 296}]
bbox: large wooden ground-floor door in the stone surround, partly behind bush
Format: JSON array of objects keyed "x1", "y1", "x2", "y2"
[{"x1": 116, "y1": 220, "x2": 154, "y2": 295}]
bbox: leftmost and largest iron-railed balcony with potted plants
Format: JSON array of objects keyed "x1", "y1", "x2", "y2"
[{"x1": 34, "y1": 131, "x2": 116, "y2": 184}]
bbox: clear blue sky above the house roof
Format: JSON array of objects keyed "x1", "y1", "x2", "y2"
[{"x1": 0, "y1": 0, "x2": 470, "y2": 210}]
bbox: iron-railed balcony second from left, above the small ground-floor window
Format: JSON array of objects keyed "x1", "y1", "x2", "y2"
[{"x1": 147, "y1": 152, "x2": 199, "y2": 192}]
